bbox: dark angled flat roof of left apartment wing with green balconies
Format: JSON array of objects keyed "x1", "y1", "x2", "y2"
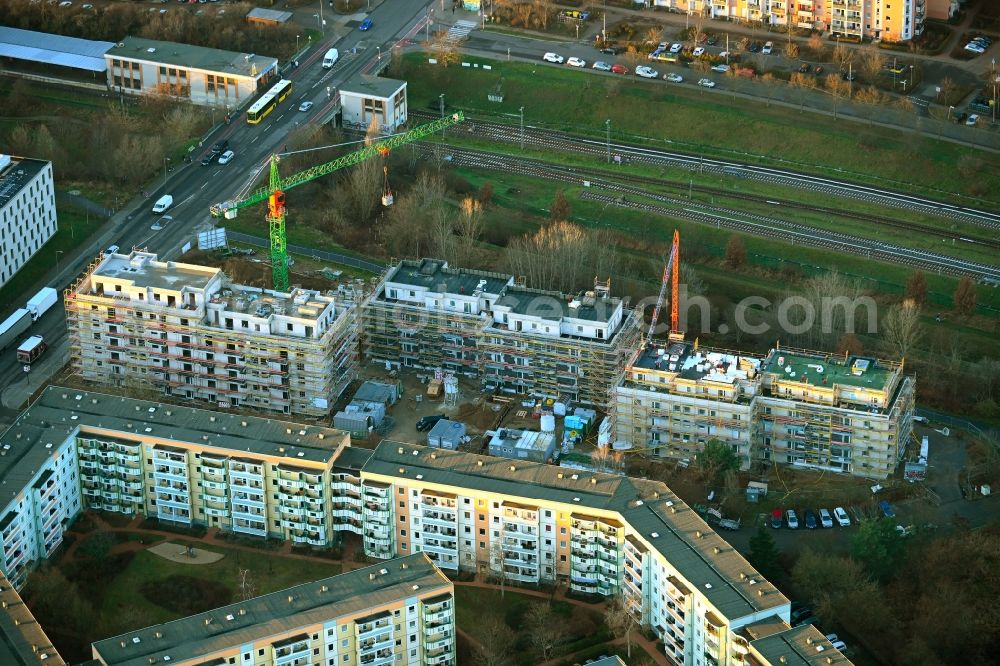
[{"x1": 0, "y1": 386, "x2": 348, "y2": 498}]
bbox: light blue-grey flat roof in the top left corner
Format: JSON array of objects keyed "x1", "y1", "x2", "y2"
[{"x1": 0, "y1": 27, "x2": 115, "y2": 72}]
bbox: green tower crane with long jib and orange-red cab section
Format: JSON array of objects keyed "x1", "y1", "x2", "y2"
[{"x1": 210, "y1": 111, "x2": 465, "y2": 291}]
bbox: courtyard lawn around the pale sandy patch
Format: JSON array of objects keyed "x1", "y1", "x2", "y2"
[{"x1": 100, "y1": 539, "x2": 341, "y2": 631}]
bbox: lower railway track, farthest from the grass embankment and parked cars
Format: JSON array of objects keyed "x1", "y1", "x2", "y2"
[{"x1": 419, "y1": 143, "x2": 1000, "y2": 284}]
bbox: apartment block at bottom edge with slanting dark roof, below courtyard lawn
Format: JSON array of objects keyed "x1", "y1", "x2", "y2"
[{"x1": 91, "y1": 553, "x2": 456, "y2": 666}]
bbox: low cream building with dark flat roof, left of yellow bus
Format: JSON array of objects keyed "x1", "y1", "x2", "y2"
[{"x1": 104, "y1": 37, "x2": 278, "y2": 110}]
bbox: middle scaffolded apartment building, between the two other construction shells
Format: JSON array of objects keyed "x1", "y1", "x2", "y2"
[{"x1": 363, "y1": 259, "x2": 639, "y2": 406}]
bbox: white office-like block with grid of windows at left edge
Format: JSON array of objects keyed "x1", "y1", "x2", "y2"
[{"x1": 0, "y1": 154, "x2": 59, "y2": 287}]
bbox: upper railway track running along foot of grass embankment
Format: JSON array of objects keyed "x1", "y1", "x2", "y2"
[{"x1": 410, "y1": 111, "x2": 1000, "y2": 231}]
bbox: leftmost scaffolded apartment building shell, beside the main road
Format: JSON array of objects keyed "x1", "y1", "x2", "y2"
[{"x1": 65, "y1": 252, "x2": 357, "y2": 417}]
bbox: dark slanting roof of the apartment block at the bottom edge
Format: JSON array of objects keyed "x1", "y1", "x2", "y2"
[{"x1": 93, "y1": 553, "x2": 453, "y2": 666}]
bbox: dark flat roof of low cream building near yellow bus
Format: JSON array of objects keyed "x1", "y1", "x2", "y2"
[{"x1": 105, "y1": 37, "x2": 278, "y2": 79}]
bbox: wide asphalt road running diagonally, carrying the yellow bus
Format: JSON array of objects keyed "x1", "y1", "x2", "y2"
[{"x1": 0, "y1": 0, "x2": 438, "y2": 416}]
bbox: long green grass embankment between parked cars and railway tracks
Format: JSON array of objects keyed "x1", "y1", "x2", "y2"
[{"x1": 393, "y1": 53, "x2": 1000, "y2": 201}]
